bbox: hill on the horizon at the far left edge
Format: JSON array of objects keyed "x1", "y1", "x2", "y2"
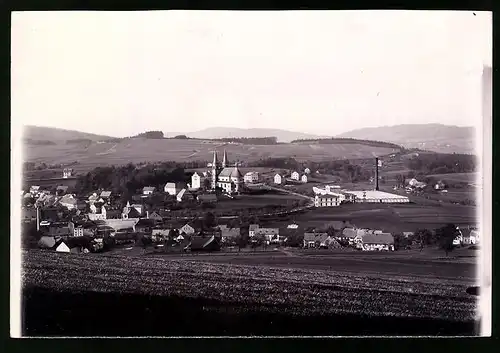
[{"x1": 23, "y1": 125, "x2": 113, "y2": 144}]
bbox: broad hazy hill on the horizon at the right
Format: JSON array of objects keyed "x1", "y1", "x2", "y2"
[{"x1": 337, "y1": 124, "x2": 475, "y2": 154}]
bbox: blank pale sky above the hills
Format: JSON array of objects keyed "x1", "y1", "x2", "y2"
[{"x1": 11, "y1": 11, "x2": 492, "y2": 137}]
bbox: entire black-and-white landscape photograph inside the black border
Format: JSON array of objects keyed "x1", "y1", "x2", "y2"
[{"x1": 10, "y1": 10, "x2": 492, "y2": 338}]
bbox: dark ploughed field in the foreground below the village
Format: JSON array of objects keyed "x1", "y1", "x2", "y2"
[{"x1": 23, "y1": 251, "x2": 476, "y2": 335}]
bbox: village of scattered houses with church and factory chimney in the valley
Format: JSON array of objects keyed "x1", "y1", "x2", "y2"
[{"x1": 21, "y1": 151, "x2": 479, "y2": 253}]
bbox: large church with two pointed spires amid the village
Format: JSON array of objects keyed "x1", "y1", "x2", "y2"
[{"x1": 191, "y1": 150, "x2": 244, "y2": 194}]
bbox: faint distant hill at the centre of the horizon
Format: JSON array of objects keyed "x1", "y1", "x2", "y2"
[{"x1": 174, "y1": 127, "x2": 328, "y2": 142}]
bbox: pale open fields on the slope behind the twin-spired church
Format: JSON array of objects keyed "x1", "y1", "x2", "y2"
[{"x1": 24, "y1": 139, "x2": 395, "y2": 171}]
